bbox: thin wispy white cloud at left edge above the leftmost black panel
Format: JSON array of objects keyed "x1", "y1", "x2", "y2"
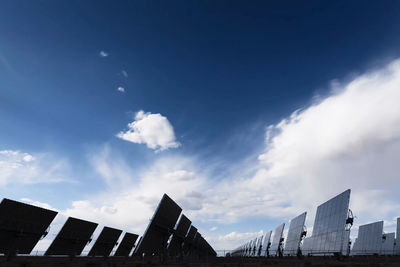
[{"x1": 0, "y1": 150, "x2": 68, "y2": 186}]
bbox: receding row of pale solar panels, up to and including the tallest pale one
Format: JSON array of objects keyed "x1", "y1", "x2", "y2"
[{"x1": 229, "y1": 189, "x2": 353, "y2": 257}]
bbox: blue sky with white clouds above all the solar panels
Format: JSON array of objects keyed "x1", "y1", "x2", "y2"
[{"x1": 0, "y1": 0, "x2": 400, "y2": 253}]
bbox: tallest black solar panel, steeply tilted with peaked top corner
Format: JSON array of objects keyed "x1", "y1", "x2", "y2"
[{"x1": 135, "y1": 194, "x2": 182, "y2": 255}]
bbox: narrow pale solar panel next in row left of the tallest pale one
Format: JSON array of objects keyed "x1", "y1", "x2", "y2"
[{"x1": 283, "y1": 212, "x2": 307, "y2": 256}]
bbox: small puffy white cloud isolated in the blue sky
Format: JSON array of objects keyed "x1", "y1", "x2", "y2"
[{"x1": 117, "y1": 110, "x2": 180, "y2": 151}]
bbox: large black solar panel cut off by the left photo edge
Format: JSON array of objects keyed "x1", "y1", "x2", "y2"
[{"x1": 0, "y1": 198, "x2": 57, "y2": 255}]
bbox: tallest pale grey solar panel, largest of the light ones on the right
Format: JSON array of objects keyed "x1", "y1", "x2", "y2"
[{"x1": 309, "y1": 189, "x2": 350, "y2": 254}]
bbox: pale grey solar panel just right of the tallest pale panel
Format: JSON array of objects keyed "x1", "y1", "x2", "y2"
[{"x1": 352, "y1": 221, "x2": 382, "y2": 255}]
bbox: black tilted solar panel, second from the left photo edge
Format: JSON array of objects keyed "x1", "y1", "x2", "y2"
[{"x1": 45, "y1": 217, "x2": 97, "y2": 256}]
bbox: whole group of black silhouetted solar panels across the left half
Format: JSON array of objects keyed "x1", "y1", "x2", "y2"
[{"x1": 0, "y1": 194, "x2": 216, "y2": 257}]
